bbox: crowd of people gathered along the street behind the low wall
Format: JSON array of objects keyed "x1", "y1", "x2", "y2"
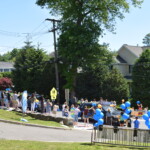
[{"x1": 0, "y1": 91, "x2": 148, "y2": 127}]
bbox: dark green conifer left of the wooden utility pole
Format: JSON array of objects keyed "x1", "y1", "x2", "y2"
[{"x1": 12, "y1": 43, "x2": 47, "y2": 92}]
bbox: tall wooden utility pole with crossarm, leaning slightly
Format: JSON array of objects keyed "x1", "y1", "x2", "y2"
[{"x1": 46, "y1": 19, "x2": 60, "y2": 103}]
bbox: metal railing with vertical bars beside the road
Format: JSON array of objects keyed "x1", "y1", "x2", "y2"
[{"x1": 91, "y1": 126, "x2": 150, "y2": 147}]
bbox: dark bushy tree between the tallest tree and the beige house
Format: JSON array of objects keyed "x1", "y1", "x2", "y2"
[{"x1": 75, "y1": 65, "x2": 109, "y2": 100}]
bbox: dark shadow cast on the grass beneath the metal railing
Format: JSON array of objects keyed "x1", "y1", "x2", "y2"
[{"x1": 80, "y1": 143, "x2": 150, "y2": 150}]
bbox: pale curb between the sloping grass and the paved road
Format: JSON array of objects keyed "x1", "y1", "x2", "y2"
[{"x1": 0, "y1": 119, "x2": 72, "y2": 130}]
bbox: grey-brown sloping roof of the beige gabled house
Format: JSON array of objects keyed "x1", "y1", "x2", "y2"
[{"x1": 123, "y1": 44, "x2": 143, "y2": 57}]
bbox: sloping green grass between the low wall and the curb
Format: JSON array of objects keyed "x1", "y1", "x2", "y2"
[{"x1": 0, "y1": 109, "x2": 62, "y2": 127}]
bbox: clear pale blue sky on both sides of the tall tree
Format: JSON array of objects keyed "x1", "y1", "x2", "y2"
[{"x1": 0, "y1": 0, "x2": 150, "y2": 54}]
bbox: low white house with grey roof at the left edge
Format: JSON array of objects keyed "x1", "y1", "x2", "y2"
[{"x1": 0, "y1": 61, "x2": 14, "y2": 72}]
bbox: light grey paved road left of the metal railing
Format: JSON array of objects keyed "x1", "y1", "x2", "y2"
[{"x1": 0, "y1": 122, "x2": 91, "y2": 142}]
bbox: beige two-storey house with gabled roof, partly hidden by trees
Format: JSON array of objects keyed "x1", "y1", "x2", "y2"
[{"x1": 112, "y1": 44, "x2": 150, "y2": 91}]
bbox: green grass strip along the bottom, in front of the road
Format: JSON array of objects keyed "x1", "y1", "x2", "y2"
[{"x1": 0, "y1": 140, "x2": 150, "y2": 150}]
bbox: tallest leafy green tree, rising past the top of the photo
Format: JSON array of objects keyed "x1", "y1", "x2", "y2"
[{"x1": 36, "y1": 0, "x2": 142, "y2": 94}]
